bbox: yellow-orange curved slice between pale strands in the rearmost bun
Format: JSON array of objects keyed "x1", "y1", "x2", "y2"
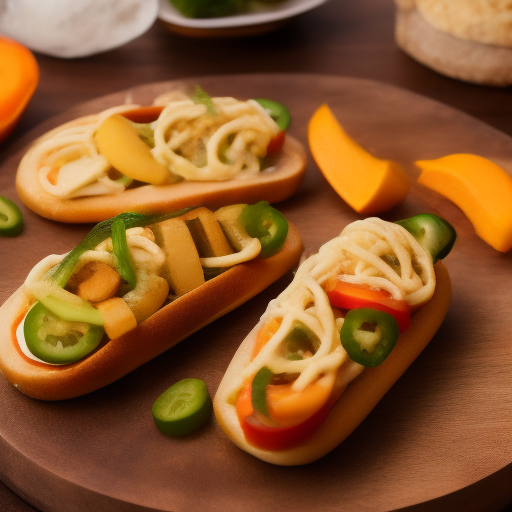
[{"x1": 95, "y1": 115, "x2": 169, "y2": 185}]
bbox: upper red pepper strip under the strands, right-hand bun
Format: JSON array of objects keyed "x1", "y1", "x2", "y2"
[{"x1": 327, "y1": 281, "x2": 411, "y2": 332}]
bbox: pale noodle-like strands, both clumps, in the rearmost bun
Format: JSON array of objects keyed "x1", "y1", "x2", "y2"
[{"x1": 33, "y1": 98, "x2": 279, "y2": 199}]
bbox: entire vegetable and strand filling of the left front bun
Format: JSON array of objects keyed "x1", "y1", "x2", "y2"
[{"x1": 17, "y1": 202, "x2": 288, "y2": 364}]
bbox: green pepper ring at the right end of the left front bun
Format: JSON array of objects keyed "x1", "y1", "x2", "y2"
[{"x1": 240, "y1": 201, "x2": 288, "y2": 258}]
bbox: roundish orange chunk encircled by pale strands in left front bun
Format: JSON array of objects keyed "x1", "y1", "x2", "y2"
[{"x1": 67, "y1": 261, "x2": 121, "y2": 303}]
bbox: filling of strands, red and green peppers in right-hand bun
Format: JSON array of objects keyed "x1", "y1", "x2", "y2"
[{"x1": 228, "y1": 218, "x2": 435, "y2": 450}]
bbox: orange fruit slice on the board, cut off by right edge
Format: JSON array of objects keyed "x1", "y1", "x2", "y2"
[{"x1": 416, "y1": 154, "x2": 512, "y2": 252}]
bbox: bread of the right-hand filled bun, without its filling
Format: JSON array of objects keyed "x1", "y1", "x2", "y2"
[{"x1": 213, "y1": 262, "x2": 451, "y2": 466}]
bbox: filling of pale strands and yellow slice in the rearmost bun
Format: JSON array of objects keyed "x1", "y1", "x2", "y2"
[{"x1": 33, "y1": 96, "x2": 284, "y2": 199}]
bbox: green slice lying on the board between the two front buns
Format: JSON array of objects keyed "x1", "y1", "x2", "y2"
[{"x1": 152, "y1": 379, "x2": 212, "y2": 437}]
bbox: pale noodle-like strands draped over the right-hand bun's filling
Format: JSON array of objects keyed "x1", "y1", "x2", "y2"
[{"x1": 234, "y1": 218, "x2": 435, "y2": 392}]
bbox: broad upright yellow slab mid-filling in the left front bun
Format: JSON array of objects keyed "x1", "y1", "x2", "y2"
[{"x1": 151, "y1": 219, "x2": 205, "y2": 295}]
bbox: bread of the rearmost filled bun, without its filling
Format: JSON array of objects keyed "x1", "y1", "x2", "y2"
[{"x1": 16, "y1": 111, "x2": 306, "y2": 223}]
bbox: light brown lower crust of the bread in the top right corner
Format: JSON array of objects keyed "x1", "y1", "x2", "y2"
[{"x1": 395, "y1": 0, "x2": 512, "y2": 87}]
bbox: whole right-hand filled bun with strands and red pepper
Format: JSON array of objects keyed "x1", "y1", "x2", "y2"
[{"x1": 214, "y1": 214, "x2": 453, "y2": 466}]
